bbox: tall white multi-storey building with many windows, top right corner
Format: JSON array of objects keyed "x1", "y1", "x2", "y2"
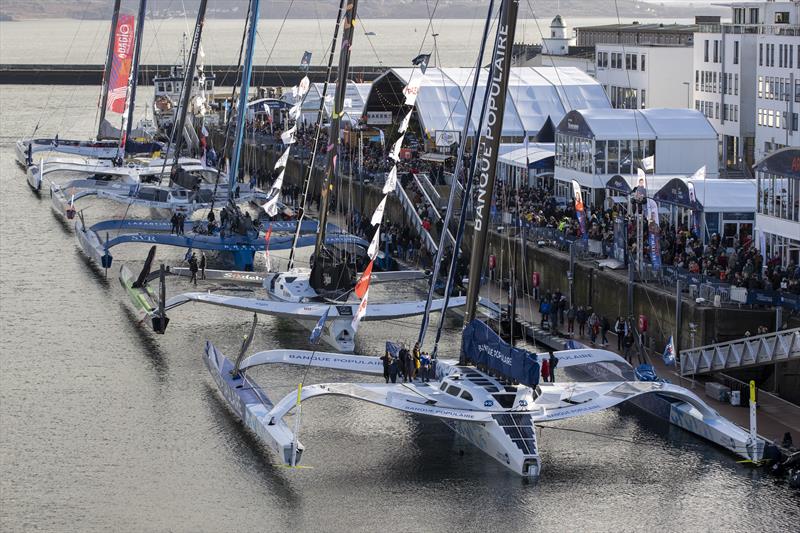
[{"x1": 692, "y1": 1, "x2": 800, "y2": 170}]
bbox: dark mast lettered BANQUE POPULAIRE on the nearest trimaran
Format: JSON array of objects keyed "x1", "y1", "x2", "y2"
[{"x1": 459, "y1": 0, "x2": 519, "y2": 364}]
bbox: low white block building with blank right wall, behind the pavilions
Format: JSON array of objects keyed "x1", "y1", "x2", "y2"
[{"x1": 595, "y1": 44, "x2": 692, "y2": 109}]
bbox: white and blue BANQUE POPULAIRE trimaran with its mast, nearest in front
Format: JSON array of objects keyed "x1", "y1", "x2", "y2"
[{"x1": 170, "y1": 0, "x2": 764, "y2": 477}]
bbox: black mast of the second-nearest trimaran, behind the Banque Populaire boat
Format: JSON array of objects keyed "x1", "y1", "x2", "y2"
[{"x1": 314, "y1": 0, "x2": 358, "y2": 259}]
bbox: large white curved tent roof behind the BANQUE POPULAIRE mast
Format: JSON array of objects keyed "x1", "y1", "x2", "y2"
[{"x1": 368, "y1": 67, "x2": 611, "y2": 137}]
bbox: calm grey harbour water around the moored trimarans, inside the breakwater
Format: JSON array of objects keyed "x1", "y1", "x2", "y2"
[{"x1": 0, "y1": 86, "x2": 800, "y2": 532}]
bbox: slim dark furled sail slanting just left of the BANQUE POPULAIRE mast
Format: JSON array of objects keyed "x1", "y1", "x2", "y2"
[{"x1": 417, "y1": 0, "x2": 494, "y2": 348}]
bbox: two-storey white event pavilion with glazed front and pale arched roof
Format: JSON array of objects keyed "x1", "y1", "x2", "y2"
[{"x1": 555, "y1": 109, "x2": 719, "y2": 204}]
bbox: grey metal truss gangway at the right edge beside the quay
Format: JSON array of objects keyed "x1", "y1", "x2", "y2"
[{"x1": 680, "y1": 328, "x2": 800, "y2": 376}]
